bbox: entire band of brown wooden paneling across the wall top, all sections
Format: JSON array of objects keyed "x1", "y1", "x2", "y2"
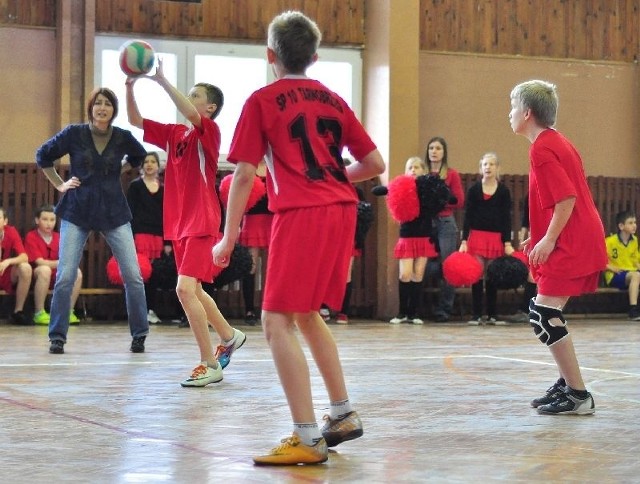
[{"x1": 0, "y1": 0, "x2": 640, "y2": 62}]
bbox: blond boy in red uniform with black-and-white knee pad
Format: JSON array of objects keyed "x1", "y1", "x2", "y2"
[{"x1": 509, "y1": 80, "x2": 607, "y2": 415}]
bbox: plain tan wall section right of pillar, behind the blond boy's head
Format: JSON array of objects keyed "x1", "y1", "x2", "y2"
[{"x1": 418, "y1": 51, "x2": 640, "y2": 177}]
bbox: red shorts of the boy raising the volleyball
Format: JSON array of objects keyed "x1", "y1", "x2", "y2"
[{"x1": 173, "y1": 235, "x2": 222, "y2": 282}]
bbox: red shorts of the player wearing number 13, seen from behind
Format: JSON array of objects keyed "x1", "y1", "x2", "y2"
[{"x1": 262, "y1": 203, "x2": 356, "y2": 313}]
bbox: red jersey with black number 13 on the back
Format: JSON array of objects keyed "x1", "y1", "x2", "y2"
[{"x1": 227, "y1": 76, "x2": 376, "y2": 213}]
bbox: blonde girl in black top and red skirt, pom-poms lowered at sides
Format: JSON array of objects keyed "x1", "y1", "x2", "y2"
[{"x1": 460, "y1": 153, "x2": 514, "y2": 325}]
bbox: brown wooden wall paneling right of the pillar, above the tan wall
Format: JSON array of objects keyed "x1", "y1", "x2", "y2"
[{"x1": 420, "y1": 0, "x2": 640, "y2": 62}]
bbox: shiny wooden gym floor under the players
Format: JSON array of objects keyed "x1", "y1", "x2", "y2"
[{"x1": 0, "y1": 316, "x2": 640, "y2": 484}]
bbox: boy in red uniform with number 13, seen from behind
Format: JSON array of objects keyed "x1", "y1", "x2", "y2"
[{"x1": 213, "y1": 11, "x2": 384, "y2": 465}]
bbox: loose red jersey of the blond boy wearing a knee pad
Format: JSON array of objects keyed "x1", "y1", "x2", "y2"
[{"x1": 529, "y1": 129, "x2": 607, "y2": 279}]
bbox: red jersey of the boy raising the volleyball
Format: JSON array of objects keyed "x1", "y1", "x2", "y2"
[{"x1": 142, "y1": 117, "x2": 221, "y2": 240}]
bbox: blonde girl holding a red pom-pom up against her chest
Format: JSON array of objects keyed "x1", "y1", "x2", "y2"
[{"x1": 387, "y1": 156, "x2": 438, "y2": 324}]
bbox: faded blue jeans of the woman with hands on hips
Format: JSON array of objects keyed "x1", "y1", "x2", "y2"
[{"x1": 49, "y1": 220, "x2": 149, "y2": 343}]
